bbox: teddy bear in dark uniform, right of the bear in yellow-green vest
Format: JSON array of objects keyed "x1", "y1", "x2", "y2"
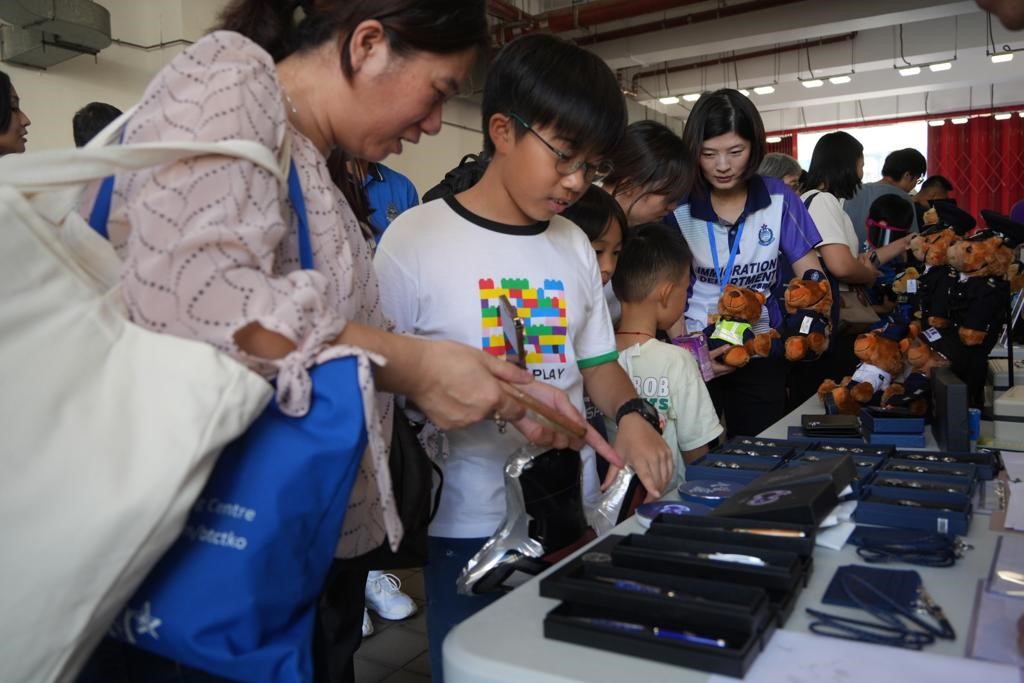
[{"x1": 782, "y1": 270, "x2": 833, "y2": 361}]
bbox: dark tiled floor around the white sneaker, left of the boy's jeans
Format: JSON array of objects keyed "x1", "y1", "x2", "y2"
[{"x1": 355, "y1": 569, "x2": 430, "y2": 683}]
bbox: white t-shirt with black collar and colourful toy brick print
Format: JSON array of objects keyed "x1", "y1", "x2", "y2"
[{"x1": 374, "y1": 193, "x2": 618, "y2": 539}]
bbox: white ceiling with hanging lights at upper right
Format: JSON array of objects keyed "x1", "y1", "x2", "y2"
[{"x1": 495, "y1": 0, "x2": 1024, "y2": 131}]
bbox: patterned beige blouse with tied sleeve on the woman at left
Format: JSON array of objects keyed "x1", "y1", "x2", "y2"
[{"x1": 96, "y1": 32, "x2": 401, "y2": 557}]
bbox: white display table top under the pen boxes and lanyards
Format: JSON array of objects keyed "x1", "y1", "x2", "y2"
[{"x1": 443, "y1": 396, "x2": 998, "y2": 683}]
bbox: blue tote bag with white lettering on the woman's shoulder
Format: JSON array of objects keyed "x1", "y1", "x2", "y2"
[{"x1": 89, "y1": 163, "x2": 367, "y2": 683}]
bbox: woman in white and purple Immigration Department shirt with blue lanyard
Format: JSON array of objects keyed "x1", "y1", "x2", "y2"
[{"x1": 666, "y1": 89, "x2": 821, "y2": 435}]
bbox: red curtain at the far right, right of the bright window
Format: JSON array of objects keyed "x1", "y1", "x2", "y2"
[{"x1": 929, "y1": 114, "x2": 1024, "y2": 225}]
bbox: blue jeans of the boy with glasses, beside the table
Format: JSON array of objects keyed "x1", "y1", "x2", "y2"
[{"x1": 423, "y1": 536, "x2": 502, "y2": 683}]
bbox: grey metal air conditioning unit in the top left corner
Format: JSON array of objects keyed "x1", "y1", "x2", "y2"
[{"x1": 0, "y1": 0, "x2": 111, "y2": 69}]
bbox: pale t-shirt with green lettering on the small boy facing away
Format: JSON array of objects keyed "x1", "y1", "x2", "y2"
[{"x1": 605, "y1": 339, "x2": 722, "y2": 488}]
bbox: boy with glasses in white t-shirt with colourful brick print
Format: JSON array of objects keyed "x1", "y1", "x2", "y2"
[{"x1": 374, "y1": 34, "x2": 673, "y2": 682}]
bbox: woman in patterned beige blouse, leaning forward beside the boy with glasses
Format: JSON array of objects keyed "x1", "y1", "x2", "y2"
[{"x1": 0, "y1": 0, "x2": 615, "y2": 680}]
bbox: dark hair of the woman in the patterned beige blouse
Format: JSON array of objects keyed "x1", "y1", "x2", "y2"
[{"x1": 218, "y1": 0, "x2": 489, "y2": 66}]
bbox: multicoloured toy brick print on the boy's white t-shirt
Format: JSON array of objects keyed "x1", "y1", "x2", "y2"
[{"x1": 479, "y1": 278, "x2": 568, "y2": 375}]
